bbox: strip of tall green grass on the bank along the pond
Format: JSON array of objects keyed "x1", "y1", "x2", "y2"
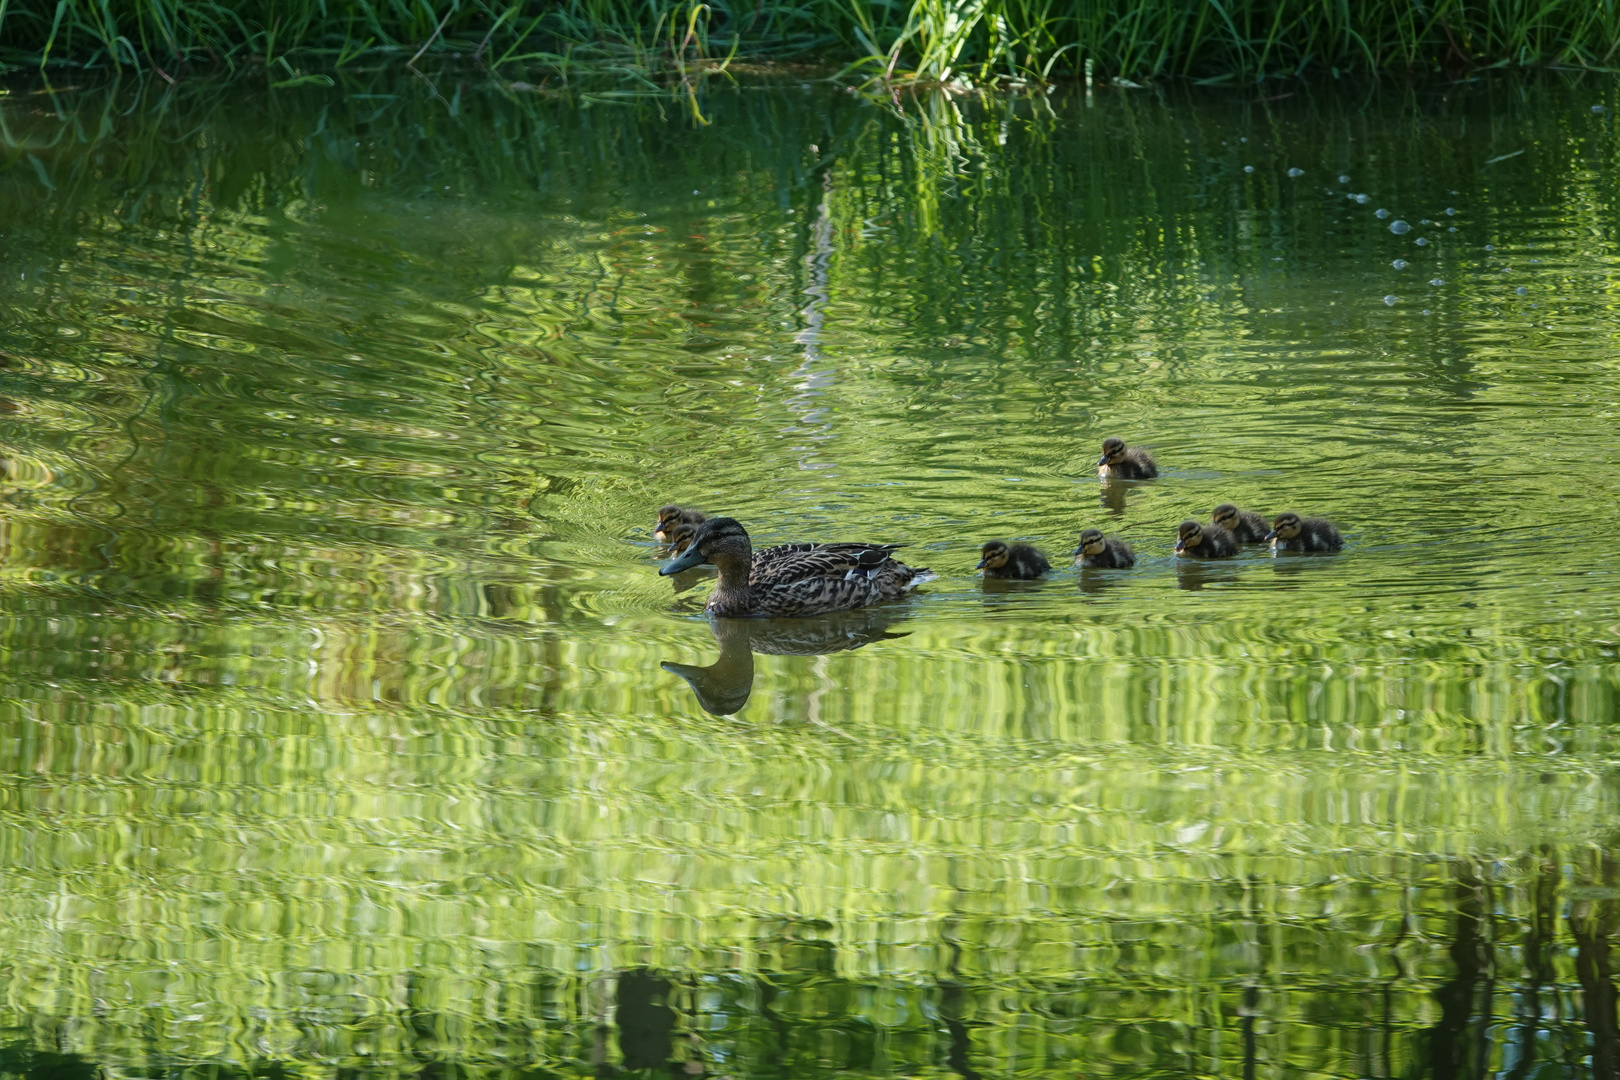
[{"x1": 0, "y1": 0, "x2": 1620, "y2": 81}]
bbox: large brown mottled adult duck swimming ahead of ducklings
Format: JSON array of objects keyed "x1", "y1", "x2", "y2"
[{"x1": 659, "y1": 518, "x2": 935, "y2": 619}]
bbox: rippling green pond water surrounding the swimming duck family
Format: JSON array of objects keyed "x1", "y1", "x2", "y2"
[{"x1": 0, "y1": 70, "x2": 1620, "y2": 1078}]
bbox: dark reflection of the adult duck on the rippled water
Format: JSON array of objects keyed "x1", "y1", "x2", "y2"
[{"x1": 659, "y1": 607, "x2": 906, "y2": 716}]
